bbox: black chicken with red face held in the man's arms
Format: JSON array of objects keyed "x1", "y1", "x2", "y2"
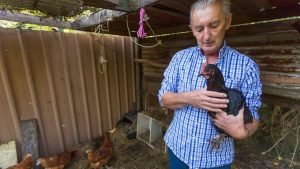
[{"x1": 200, "y1": 64, "x2": 253, "y2": 148}]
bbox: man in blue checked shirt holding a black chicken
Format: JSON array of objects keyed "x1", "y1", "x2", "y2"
[{"x1": 158, "y1": 0, "x2": 262, "y2": 169}]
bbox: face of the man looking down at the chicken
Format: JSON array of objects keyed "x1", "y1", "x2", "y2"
[{"x1": 191, "y1": 3, "x2": 231, "y2": 55}]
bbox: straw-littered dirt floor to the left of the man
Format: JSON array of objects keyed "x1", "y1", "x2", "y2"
[{"x1": 67, "y1": 120, "x2": 168, "y2": 169}]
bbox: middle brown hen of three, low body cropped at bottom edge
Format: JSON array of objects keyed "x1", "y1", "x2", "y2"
[{"x1": 37, "y1": 151, "x2": 76, "y2": 169}]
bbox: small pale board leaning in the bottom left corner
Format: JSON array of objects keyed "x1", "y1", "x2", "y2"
[{"x1": 0, "y1": 141, "x2": 17, "y2": 168}]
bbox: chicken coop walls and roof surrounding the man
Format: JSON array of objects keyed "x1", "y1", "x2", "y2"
[{"x1": 0, "y1": 0, "x2": 300, "y2": 167}]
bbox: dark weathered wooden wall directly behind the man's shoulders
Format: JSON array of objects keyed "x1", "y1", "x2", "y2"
[{"x1": 142, "y1": 25, "x2": 300, "y2": 106}]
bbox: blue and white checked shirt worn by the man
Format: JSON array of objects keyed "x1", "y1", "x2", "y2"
[{"x1": 158, "y1": 43, "x2": 262, "y2": 169}]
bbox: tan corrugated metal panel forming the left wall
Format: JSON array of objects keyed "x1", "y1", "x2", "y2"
[{"x1": 0, "y1": 29, "x2": 136, "y2": 156}]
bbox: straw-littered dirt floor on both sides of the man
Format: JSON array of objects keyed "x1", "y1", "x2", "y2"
[{"x1": 67, "y1": 109, "x2": 296, "y2": 169}]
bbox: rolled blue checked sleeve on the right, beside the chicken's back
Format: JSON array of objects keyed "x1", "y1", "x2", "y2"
[{"x1": 242, "y1": 62, "x2": 262, "y2": 120}]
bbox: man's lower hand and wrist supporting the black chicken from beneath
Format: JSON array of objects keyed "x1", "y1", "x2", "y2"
[{"x1": 212, "y1": 107, "x2": 259, "y2": 140}]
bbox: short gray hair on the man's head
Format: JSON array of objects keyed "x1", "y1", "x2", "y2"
[{"x1": 190, "y1": 0, "x2": 231, "y2": 17}]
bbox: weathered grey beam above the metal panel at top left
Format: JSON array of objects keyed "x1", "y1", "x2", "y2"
[{"x1": 0, "y1": 10, "x2": 71, "y2": 28}]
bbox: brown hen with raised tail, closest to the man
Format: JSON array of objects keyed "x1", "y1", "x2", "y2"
[{"x1": 86, "y1": 132, "x2": 113, "y2": 168}]
